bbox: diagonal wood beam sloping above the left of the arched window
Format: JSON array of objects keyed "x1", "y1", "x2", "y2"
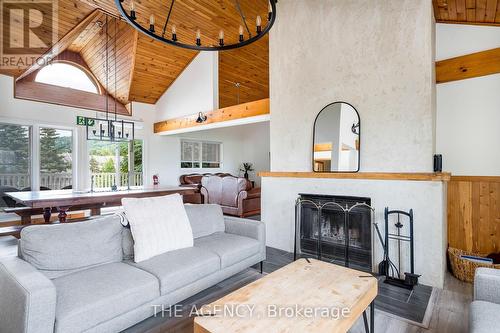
[{"x1": 17, "y1": 9, "x2": 102, "y2": 80}]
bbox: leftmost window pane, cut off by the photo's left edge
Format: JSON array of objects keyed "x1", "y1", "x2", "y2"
[{"x1": 0, "y1": 124, "x2": 31, "y2": 208}]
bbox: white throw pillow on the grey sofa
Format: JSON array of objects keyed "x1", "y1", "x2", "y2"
[{"x1": 122, "y1": 194, "x2": 193, "y2": 262}]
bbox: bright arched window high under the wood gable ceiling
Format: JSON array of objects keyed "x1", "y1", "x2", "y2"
[{"x1": 35, "y1": 62, "x2": 99, "y2": 94}]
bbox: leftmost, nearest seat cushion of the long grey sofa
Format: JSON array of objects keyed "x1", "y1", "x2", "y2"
[{"x1": 53, "y1": 263, "x2": 160, "y2": 333}]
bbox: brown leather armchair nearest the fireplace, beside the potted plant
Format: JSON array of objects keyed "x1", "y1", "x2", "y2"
[{"x1": 200, "y1": 175, "x2": 260, "y2": 217}]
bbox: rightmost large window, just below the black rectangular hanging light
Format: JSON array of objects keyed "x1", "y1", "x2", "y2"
[{"x1": 88, "y1": 140, "x2": 143, "y2": 189}]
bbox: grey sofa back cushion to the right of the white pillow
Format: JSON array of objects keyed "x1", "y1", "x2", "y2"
[{"x1": 184, "y1": 205, "x2": 225, "y2": 238}]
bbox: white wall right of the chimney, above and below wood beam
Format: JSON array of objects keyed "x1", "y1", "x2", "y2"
[{"x1": 436, "y1": 24, "x2": 500, "y2": 176}]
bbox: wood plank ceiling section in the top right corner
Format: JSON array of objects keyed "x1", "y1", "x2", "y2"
[{"x1": 433, "y1": 0, "x2": 500, "y2": 26}]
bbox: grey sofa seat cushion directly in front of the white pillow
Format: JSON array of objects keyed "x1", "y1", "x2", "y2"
[{"x1": 129, "y1": 247, "x2": 220, "y2": 295}]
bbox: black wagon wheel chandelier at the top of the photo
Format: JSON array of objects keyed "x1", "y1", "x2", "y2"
[{"x1": 115, "y1": 0, "x2": 278, "y2": 51}]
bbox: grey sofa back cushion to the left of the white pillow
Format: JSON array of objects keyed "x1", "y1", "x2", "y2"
[{"x1": 19, "y1": 216, "x2": 123, "y2": 279}]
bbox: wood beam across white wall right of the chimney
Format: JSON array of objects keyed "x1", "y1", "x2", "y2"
[{"x1": 436, "y1": 48, "x2": 500, "y2": 83}]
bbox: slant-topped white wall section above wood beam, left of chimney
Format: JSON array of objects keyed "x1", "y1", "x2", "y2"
[{"x1": 156, "y1": 52, "x2": 219, "y2": 121}]
